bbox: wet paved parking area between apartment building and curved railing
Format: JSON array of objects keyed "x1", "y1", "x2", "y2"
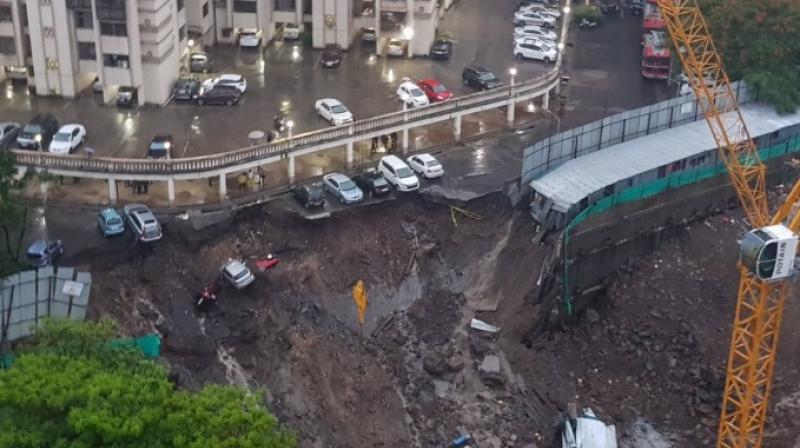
[{"x1": 0, "y1": 0, "x2": 552, "y2": 158}]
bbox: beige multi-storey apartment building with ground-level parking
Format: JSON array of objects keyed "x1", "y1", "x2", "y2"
[{"x1": 0, "y1": 0, "x2": 449, "y2": 104}]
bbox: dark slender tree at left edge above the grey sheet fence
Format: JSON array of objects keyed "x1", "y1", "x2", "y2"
[{"x1": 0, "y1": 150, "x2": 28, "y2": 277}]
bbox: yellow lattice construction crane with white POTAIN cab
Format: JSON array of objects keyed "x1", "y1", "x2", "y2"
[{"x1": 657, "y1": 0, "x2": 800, "y2": 448}]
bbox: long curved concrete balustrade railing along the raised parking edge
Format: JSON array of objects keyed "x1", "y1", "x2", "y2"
[{"x1": 13, "y1": 65, "x2": 560, "y2": 175}]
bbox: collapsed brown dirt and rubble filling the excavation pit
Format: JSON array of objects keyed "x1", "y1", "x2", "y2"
[{"x1": 75, "y1": 194, "x2": 800, "y2": 448}]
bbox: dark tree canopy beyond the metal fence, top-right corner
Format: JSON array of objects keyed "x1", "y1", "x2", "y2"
[{"x1": 699, "y1": 0, "x2": 800, "y2": 112}]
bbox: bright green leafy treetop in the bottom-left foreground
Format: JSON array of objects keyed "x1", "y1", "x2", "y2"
[{"x1": 0, "y1": 321, "x2": 296, "y2": 448}]
